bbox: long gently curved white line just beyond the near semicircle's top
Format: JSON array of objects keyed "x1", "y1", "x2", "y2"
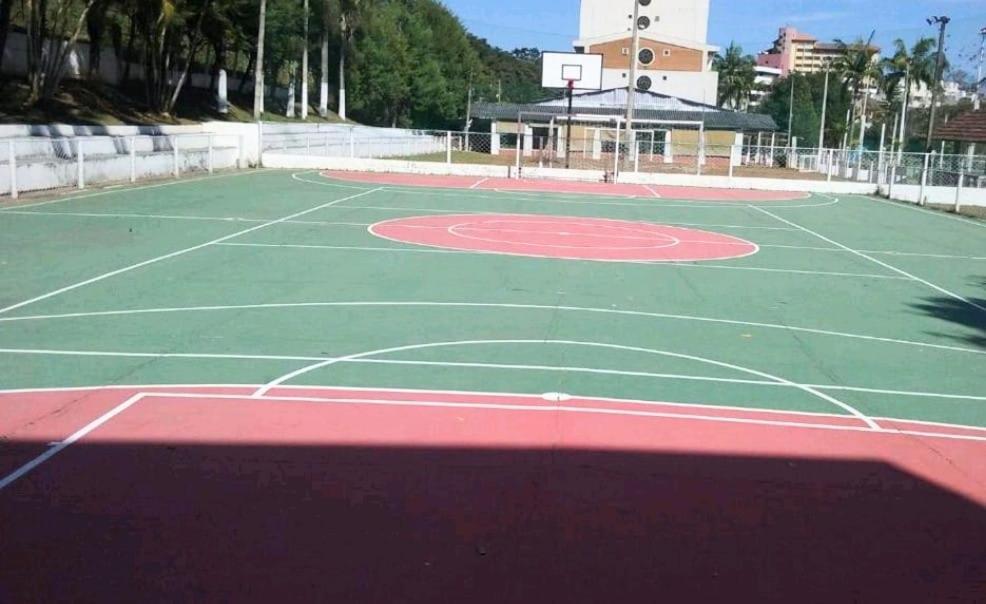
[{"x1": 0, "y1": 300, "x2": 986, "y2": 354}]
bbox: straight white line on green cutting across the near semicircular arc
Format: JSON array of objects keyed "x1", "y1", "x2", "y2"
[{"x1": 0, "y1": 348, "x2": 986, "y2": 402}]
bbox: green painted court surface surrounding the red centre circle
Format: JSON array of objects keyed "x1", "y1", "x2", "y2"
[{"x1": 0, "y1": 171, "x2": 986, "y2": 427}]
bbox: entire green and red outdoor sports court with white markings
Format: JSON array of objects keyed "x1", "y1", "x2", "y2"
[{"x1": 0, "y1": 171, "x2": 986, "y2": 602}]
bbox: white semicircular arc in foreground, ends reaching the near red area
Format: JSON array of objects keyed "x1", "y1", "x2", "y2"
[{"x1": 254, "y1": 340, "x2": 880, "y2": 430}]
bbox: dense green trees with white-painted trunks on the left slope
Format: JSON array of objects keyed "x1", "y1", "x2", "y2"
[{"x1": 0, "y1": 0, "x2": 544, "y2": 128}]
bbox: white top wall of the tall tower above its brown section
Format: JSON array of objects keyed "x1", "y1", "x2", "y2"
[{"x1": 579, "y1": 0, "x2": 709, "y2": 44}]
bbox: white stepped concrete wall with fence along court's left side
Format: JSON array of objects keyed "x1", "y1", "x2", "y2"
[{"x1": 0, "y1": 134, "x2": 244, "y2": 198}]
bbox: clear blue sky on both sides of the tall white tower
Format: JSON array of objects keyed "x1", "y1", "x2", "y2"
[{"x1": 444, "y1": 0, "x2": 986, "y2": 70}]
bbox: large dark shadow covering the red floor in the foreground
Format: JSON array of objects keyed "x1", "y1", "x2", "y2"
[{"x1": 0, "y1": 442, "x2": 986, "y2": 603}]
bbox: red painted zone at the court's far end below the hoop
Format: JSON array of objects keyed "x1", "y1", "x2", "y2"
[{"x1": 322, "y1": 171, "x2": 810, "y2": 203}]
